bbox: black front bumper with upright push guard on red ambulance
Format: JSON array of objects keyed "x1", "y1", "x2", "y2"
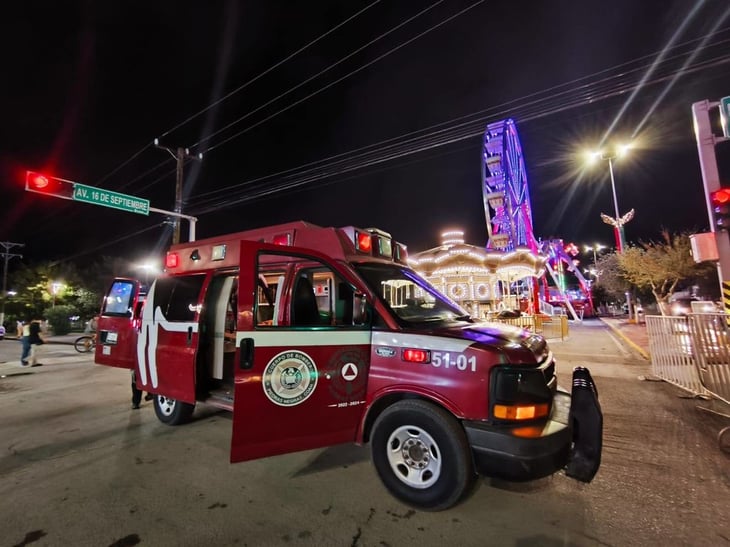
[{"x1": 463, "y1": 367, "x2": 603, "y2": 482}]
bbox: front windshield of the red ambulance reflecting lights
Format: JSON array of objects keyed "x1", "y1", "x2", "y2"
[{"x1": 355, "y1": 263, "x2": 469, "y2": 323}]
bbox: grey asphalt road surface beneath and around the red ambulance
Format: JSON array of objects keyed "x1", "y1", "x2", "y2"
[{"x1": 0, "y1": 321, "x2": 730, "y2": 546}]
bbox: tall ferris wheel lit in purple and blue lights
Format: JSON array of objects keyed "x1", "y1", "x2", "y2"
[{"x1": 482, "y1": 119, "x2": 537, "y2": 252}]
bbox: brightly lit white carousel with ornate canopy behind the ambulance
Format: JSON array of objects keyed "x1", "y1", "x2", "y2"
[{"x1": 408, "y1": 230, "x2": 547, "y2": 319}]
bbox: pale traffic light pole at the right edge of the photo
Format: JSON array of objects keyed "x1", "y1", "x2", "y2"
[{"x1": 692, "y1": 100, "x2": 730, "y2": 315}]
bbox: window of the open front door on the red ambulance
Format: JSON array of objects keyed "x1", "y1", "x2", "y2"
[{"x1": 256, "y1": 254, "x2": 355, "y2": 327}]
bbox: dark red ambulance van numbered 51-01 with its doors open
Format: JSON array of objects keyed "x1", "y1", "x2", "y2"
[{"x1": 95, "y1": 222, "x2": 602, "y2": 510}]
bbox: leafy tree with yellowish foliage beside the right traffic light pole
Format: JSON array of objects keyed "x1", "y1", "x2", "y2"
[{"x1": 617, "y1": 230, "x2": 709, "y2": 315}]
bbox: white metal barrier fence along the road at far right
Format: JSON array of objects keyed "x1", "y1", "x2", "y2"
[{"x1": 646, "y1": 313, "x2": 730, "y2": 404}]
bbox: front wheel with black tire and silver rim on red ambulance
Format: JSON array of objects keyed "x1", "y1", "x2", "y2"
[{"x1": 371, "y1": 399, "x2": 476, "y2": 511}]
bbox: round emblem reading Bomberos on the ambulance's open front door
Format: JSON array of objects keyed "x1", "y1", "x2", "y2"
[{"x1": 262, "y1": 350, "x2": 317, "y2": 406}]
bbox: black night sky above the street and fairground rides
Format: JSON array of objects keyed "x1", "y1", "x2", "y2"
[{"x1": 0, "y1": 0, "x2": 730, "y2": 272}]
